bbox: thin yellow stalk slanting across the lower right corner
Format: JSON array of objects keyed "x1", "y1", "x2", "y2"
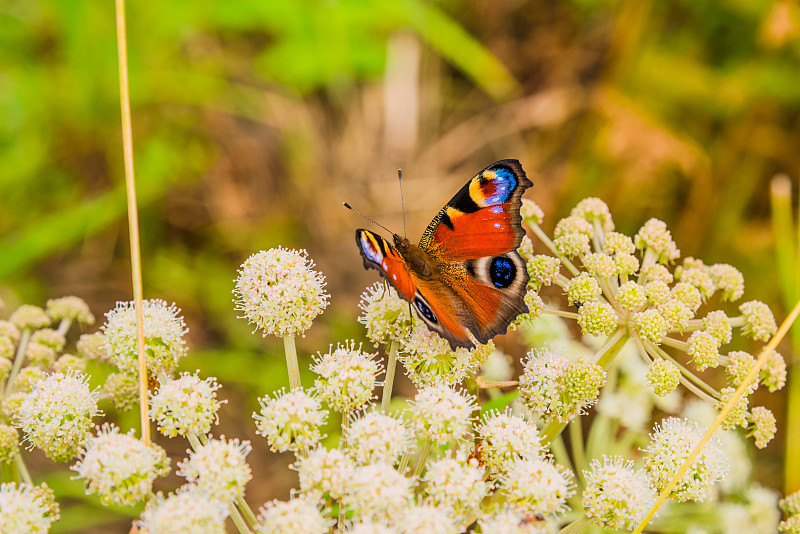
[{"x1": 636, "y1": 300, "x2": 800, "y2": 534}]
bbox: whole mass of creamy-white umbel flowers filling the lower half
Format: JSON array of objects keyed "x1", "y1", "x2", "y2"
[{"x1": 0, "y1": 199, "x2": 788, "y2": 534}]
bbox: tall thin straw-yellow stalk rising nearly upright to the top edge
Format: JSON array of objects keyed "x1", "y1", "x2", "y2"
[{"x1": 116, "y1": 0, "x2": 150, "y2": 445}]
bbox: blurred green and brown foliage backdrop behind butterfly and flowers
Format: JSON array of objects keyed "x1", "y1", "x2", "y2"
[{"x1": 0, "y1": 0, "x2": 800, "y2": 528}]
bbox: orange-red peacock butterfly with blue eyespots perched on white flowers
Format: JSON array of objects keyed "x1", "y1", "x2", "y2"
[{"x1": 356, "y1": 160, "x2": 533, "y2": 348}]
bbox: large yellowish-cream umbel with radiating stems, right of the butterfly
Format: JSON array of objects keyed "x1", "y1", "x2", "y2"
[{"x1": 520, "y1": 198, "x2": 786, "y2": 447}]
